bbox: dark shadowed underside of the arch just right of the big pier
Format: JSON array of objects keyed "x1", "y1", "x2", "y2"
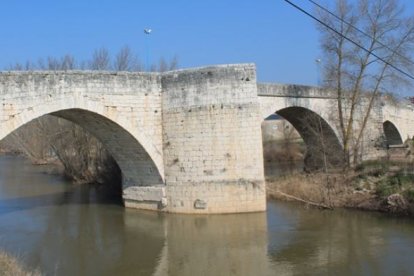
[{"x1": 266, "y1": 106, "x2": 343, "y2": 169}]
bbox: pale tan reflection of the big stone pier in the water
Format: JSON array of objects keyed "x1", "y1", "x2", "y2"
[{"x1": 163, "y1": 213, "x2": 269, "y2": 275}]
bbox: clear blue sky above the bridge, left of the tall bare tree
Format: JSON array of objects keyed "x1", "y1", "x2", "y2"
[{"x1": 0, "y1": 0, "x2": 414, "y2": 94}]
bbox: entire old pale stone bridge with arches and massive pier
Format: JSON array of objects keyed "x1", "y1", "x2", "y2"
[{"x1": 0, "y1": 64, "x2": 414, "y2": 213}]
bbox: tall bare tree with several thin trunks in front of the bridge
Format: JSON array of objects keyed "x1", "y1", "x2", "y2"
[{"x1": 319, "y1": 0, "x2": 414, "y2": 167}]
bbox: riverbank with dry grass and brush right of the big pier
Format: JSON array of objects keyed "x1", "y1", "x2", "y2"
[{"x1": 266, "y1": 162, "x2": 414, "y2": 216}]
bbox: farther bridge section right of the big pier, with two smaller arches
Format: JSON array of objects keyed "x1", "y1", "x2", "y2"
[{"x1": 257, "y1": 81, "x2": 414, "y2": 164}]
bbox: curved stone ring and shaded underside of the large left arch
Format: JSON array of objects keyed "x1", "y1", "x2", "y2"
[{"x1": 0, "y1": 94, "x2": 164, "y2": 189}]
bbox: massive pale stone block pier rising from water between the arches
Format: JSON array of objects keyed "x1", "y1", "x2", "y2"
[{"x1": 162, "y1": 64, "x2": 266, "y2": 213}]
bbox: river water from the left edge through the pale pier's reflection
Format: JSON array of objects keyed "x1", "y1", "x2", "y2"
[{"x1": 0, "y1": 157, "x2": 267, "y2": 275}]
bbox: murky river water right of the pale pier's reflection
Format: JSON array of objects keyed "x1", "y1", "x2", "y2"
[{"x1": 268, "y1": 202, "x2": 414, "y2": 275}]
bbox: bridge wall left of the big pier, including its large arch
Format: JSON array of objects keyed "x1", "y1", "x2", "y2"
[{"x1": 0, "y1": 71, "x2": 164, "y2": 194}]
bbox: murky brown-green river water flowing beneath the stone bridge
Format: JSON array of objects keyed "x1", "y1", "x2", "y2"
[{"x1": 0, "y1": 156, "x2": 414, "y2": 275}]
